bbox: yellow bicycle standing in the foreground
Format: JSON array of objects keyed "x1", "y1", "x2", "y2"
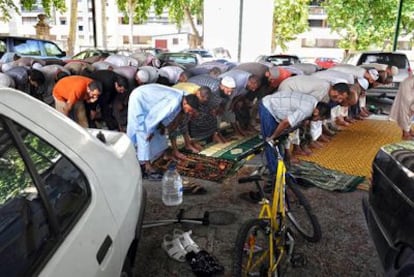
[{"x1": 233, "y1": 139, "x2": 321, "y2": 276}]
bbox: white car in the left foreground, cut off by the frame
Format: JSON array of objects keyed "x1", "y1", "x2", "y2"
[{"x1": 0, "y1": 88, "x2": 146, "y2": 277}]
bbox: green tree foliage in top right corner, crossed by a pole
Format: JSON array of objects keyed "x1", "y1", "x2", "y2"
[{"x1": 322, "y1": 0, "x2": 414, "y2": 50}]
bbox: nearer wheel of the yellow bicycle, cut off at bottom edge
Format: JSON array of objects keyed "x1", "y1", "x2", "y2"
[{"x1": 233, "y1": 219, "x2": 279, "y2": 277}]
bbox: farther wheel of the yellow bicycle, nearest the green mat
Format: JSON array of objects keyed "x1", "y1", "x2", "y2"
[{"x1": 286, "y1": 176, "x2": 322, "y2": 242}]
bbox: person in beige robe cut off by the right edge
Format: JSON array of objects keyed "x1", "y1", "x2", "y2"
[{"x1": 390, "y1": 75, "x2": 414, "y2": 140}]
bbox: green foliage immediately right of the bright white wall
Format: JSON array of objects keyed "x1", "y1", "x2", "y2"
[{"x1": 272, "y1": 0, "x2": 309, "y2": 51}]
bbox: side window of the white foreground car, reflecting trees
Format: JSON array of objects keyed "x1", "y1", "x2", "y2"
[{"x1": 0, "y1": 118, "x2": 90, "y2": 276}]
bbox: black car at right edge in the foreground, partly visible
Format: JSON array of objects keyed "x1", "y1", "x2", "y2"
[{"x1": 363, "y1": 141, "x2": 414, "y2": 276}]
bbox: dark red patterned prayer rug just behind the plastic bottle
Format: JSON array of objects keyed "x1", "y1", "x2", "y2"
[{"x1": 153, "y1": 153, "x2": 236, "y2": 182}]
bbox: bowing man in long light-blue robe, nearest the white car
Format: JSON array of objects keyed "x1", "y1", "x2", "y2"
[{"x1": 127, "y1": 84, "x2": 199, "y2": 177}]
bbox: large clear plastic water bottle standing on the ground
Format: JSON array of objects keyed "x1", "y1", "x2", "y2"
[{"x1": 162, "y1": 163, "x2": 183, "y2": 206}]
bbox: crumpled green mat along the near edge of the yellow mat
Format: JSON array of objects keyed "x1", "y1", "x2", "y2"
[{"x1": 289, "y1": 161, "x2": 365, "y2": 192}]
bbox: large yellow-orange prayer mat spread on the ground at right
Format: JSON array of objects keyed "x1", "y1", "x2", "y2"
[{"x1": 299, "y1": 119, "x2": 401, "y2": 180}]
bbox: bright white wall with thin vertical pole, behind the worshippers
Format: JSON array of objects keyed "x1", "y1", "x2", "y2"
[{"x1": 204, "y1": 0, "x2": 273, "y2": 62}]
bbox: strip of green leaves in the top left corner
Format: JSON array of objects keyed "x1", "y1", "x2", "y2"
[{"x1": 0, "y1": 0, "x2": 66, "y2": 21}]
